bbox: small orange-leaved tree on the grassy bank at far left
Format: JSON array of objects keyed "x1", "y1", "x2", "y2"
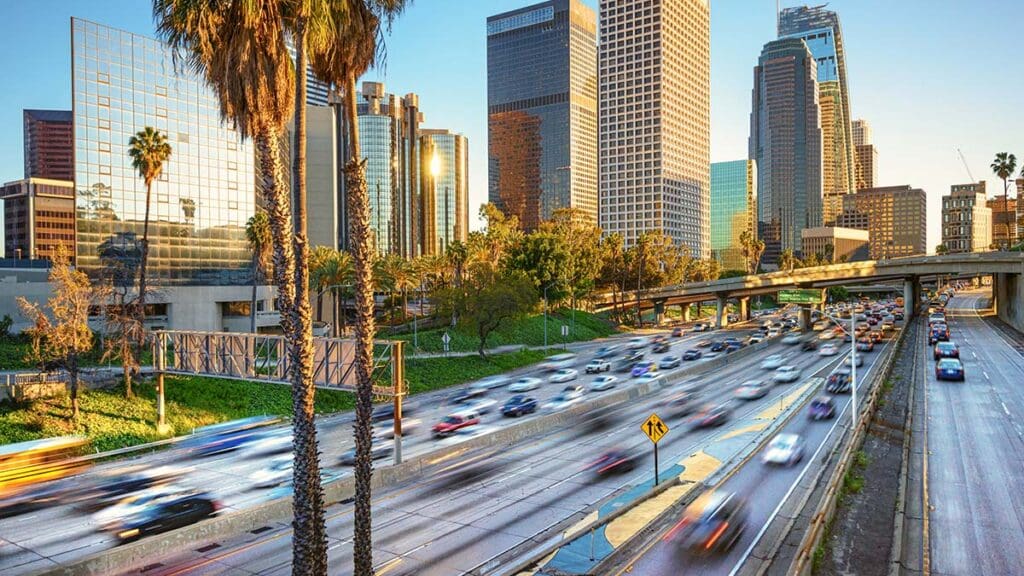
[{"x1": 17, "y1": 244, "x2": 106, "y2": 419}]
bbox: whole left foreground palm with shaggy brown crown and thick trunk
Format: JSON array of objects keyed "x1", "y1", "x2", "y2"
[{"x1": 154, "y1": 0, "x2": 327, "y2": 575}]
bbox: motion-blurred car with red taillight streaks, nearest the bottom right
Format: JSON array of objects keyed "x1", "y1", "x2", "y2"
[{"x1": 665, "y1": 490, "x2": 748, "y2": 556}]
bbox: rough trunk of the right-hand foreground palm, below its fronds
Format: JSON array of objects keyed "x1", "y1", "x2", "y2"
[{"x1": 344, "y1": 75, "x2": 374, "y2": 576}]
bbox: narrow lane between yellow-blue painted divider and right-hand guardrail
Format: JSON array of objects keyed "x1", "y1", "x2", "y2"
[{"x1": 610, "y1": 334, "x2": 891, "y2": 576}]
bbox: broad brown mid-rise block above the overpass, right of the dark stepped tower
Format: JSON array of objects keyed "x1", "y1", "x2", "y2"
[{"x1": 837, "y1": 186, "x2": 928, "y2": 256}]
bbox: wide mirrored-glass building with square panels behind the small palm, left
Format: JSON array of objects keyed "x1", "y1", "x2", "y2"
[{"x1": 72, "y1": 18, "x2": 256, "y2": 285}]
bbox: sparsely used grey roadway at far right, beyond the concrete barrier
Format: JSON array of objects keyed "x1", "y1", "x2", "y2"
[{"x1": 924, "y1": 297, "x2": 1024, "y2": 574}]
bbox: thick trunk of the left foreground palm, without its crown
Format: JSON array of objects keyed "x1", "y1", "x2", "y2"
[{"x1": 253, "y1": 127, "x2": 327, "y2": 575}]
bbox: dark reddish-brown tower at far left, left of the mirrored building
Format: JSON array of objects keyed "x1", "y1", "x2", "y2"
[{"x1": 23, "y1": 110, "x2": 75, "y2": 180}]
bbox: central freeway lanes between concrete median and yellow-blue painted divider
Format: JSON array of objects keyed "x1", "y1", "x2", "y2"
[{"x1": 103, "y1": 323, "x2": 881, "y2": 576}]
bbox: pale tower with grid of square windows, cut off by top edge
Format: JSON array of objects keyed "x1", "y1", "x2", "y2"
[{"x1": 598, "y1": 0, "x2": 712, "y2": 258}]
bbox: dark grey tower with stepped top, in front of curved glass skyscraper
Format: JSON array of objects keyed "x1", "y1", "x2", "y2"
[{"x1": 749, "y1": 38, "x2": 823, "y2": 263}]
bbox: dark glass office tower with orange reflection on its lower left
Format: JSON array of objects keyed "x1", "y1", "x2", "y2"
[{"x1": 487, "y1": 0, "x2": 597, "y2": 231}]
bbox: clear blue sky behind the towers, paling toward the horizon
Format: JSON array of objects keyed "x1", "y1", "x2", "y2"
[{"x1": 0, "y1": 0, "x2": 1024, "y2": 247}]
